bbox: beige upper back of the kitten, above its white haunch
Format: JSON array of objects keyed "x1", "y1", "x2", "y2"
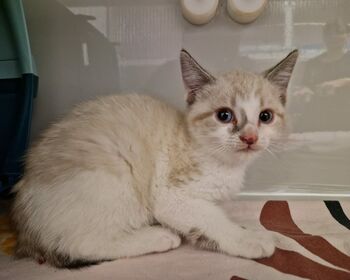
[{"x1": 26, "y1": 94, "x2": 183, "y2": 186}]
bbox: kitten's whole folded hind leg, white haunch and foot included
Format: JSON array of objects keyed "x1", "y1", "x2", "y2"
[{"x1": 17, "y1": 170, "x2": 180, "y2": 267}]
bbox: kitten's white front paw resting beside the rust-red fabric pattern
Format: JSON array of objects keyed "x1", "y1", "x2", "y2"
[{"x1": 222, "y1": 230, "x2": 275, "y2": 259}]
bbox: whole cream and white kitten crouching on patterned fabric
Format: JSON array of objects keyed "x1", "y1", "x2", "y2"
[{"x1": 13, "y1": 51, "x2": 298, "y2": 268}]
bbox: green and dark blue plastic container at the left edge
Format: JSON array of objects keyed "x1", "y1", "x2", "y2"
[{"x1": 0, "y1": 0, "x2": 38, "y2": 195}]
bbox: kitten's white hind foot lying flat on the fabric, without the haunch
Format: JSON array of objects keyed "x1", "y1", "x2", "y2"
[{"x1": 43, "y1": 226, "x2": 181, "y2": 268}]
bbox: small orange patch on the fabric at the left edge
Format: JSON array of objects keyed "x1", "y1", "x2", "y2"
[{"x1": 0, "y1": 216, "x2": 16, "y2": 255}]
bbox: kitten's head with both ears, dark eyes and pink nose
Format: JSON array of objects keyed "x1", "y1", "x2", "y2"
[{"x1": 180, "y1": 50, "x2": 298, "y2": 164}]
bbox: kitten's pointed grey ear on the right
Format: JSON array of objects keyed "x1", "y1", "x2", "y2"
[{"x1": 263, "y1": 50, "x2": 299, "y2": 105}]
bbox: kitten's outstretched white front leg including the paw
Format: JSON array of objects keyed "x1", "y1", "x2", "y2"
[{"x1": 155, "y1": 189, "x2": 275, "y2": 258}]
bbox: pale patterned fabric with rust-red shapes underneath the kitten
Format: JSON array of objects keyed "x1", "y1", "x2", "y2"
[{"x1": 0, "y1": 201, "x2": 350, "y2": 280}]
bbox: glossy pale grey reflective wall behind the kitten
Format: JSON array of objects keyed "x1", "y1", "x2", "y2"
[{"x1": 23, "y1": 0, "x2": 350, "y2": 198}]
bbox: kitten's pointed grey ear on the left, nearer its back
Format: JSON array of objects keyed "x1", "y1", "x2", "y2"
[{"x1": 180, "y1": 49, "x2": 215, "y2": 105}]
